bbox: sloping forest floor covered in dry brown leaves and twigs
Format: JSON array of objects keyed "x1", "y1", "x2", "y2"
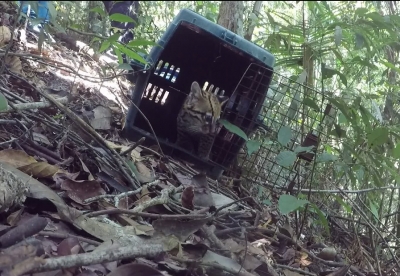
[{"x1": 0, "y1": 4, "x2": 382, "y2": 276}]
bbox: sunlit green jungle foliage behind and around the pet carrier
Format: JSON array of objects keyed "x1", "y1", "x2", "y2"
[{"x1": 7, "y1": 1, "x2": 400, "y2": 274}]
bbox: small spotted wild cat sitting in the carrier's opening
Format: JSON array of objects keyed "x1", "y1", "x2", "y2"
[{"x1": 176, "y1": 81, "x2": 229, "y2": 159}]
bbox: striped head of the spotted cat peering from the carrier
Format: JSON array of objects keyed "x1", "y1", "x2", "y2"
[{"x1": 186, "y1": 81, "x2": 229, "y2": 134}]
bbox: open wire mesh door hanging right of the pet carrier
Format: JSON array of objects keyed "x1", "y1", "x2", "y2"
[{"x1": 226, "y1": 64, "x2": 336, "y2": 194}]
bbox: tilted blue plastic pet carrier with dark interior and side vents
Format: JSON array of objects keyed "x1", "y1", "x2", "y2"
[{"x1": 122, "y1": 9, "x2": 275, "y2": 178}]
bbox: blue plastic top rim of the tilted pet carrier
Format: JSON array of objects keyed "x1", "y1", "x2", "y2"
[{"x1": 148, "y1": 9, "x2": 275, "y2": 68}]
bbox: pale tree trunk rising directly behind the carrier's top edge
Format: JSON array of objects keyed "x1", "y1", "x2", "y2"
[{"x1": 217, "y1": 1, "x2": 244, "y2": 36}]
